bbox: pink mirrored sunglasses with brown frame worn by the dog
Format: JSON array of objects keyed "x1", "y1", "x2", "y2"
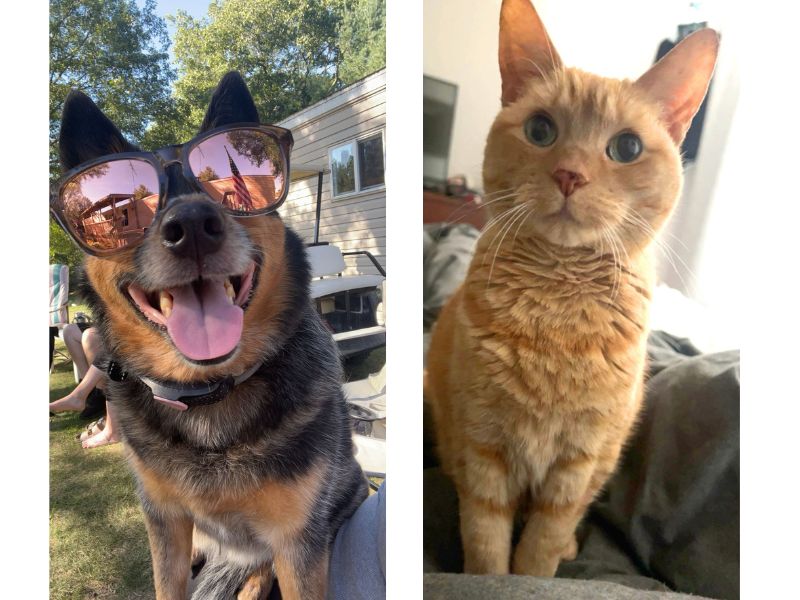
[{"x1": 50, "y1": 124, "x2": 293, "y2": 256}]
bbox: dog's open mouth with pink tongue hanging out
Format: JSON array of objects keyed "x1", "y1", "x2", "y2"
[{"x1": 128, "y1": 262, "x2": 256, "y2": 361}]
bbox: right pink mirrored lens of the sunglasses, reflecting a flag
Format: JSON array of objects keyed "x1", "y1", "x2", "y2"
[{"x1": 189, "y1": 129, "x2": 286, "y2": 212}]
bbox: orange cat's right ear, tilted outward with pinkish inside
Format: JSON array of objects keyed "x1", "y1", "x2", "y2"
[{"x1": 634, "y1": 29, "x2": 719, "y2": 145}]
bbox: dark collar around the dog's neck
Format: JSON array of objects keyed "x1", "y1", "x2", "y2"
[{"x1": 107, "y1": 360, "x2": 261, "y2": 411}]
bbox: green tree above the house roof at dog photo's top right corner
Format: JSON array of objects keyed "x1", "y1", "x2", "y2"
[{"x1": 339, "y1": 0, "x2": 386, "y2": 85}]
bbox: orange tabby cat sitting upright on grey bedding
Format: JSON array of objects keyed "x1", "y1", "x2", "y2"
[{"x1": 426, "y1": 0, "x2": 718, "y2": 576}]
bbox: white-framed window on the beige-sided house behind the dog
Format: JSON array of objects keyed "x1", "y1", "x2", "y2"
[{"x1": 330, "y1": 133, "x2": 384, "y2": 197}]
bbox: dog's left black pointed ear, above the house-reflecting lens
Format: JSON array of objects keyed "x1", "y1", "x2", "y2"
[{"x1": 58, "y1": 90, "x2": 137, "y2": 171}]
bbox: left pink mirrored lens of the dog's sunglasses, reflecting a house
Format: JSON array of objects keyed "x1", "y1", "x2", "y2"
[{"x1": 61, "y1": 159, "x2": 159, "y2": 251}]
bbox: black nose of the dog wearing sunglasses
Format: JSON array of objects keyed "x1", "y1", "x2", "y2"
[{"x1": 161, "y1": 202, "x2": 225, "y2": 259}]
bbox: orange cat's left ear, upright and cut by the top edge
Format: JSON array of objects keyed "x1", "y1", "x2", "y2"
[{"x1": 499, "y1": 0, "x2": 561, "y2": 106}]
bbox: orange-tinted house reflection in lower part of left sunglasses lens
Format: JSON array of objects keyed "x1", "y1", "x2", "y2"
[{"x1": 79, "y1": 188, "x2": 158, "y2": 249}]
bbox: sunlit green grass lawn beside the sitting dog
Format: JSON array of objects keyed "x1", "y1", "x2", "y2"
[{"x1": 50, "y1": 340, "x2": 385, "y2": 600}]
